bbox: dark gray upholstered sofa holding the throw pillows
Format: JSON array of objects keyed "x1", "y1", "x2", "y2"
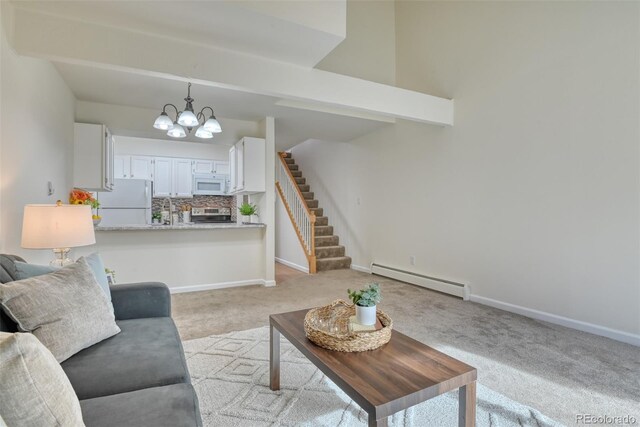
[{"x1": 0, "y1": 255, "x2": 202, "y2": 427}]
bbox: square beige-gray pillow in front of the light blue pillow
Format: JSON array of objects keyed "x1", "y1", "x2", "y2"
[{"x1": 0, "y1": 259, "x2": 120, "y2": 362}]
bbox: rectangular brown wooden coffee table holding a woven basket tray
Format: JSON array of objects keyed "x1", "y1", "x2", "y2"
[{"x1": 269, "y1": 310, "x2": 477, "y2": 427}]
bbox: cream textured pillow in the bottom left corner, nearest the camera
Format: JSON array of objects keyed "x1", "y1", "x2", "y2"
[{"x1": 0, "y1": 332, "x2": 84, "y2": 427}]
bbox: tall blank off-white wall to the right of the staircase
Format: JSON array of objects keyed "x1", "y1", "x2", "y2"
[{"x1": 286, "y1": 1, "x2": 640, "y2": 342}]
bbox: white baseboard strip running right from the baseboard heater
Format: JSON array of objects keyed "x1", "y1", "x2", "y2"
[{"x1": 469, "y1": 294, "x2": 640, "y2": 346}]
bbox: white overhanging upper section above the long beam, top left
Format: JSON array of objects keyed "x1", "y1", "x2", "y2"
[{"x1": 12, "y1": 0, "x2": 346, "y2": 67}]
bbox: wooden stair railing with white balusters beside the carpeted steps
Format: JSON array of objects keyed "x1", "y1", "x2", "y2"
[{"x1": 276, "y1": 153, "x2": 316, "y2": 274}]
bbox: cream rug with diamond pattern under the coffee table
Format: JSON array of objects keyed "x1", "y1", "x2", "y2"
[{"x1": 183, "y1": 327, "x2": 562, "y2": 427}]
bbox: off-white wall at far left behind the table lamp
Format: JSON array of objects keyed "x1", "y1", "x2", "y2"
[{"x1": 0, "y1": 4, "x2": 75, "y2": 263}]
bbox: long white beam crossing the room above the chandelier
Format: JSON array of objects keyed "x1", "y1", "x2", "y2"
[{"x1": 8, "y1": 8, "x2": 453, "y2": 125}]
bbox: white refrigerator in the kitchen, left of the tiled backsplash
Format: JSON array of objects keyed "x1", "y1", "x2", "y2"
[{"x1": 97, "y1": 179, "x2": 151, "y2": 227}]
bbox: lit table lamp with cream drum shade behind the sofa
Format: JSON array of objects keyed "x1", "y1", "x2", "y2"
[{"x1": 22, "y1": 201, "x2": 96, "y2": 267}]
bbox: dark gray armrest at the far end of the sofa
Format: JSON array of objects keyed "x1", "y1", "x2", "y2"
[{"x1": 109, "y1": 282, "x2": 171, "y2": 320}]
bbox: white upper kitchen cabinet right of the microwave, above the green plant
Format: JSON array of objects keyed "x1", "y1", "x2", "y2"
[{"x1": 229, "y1": 137, "x2": 265, "y2": 194}]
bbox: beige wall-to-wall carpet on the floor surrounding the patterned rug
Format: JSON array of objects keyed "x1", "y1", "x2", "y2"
[{"x1": 173, "y1": 270, "x2": 640, "y2": 425}]
